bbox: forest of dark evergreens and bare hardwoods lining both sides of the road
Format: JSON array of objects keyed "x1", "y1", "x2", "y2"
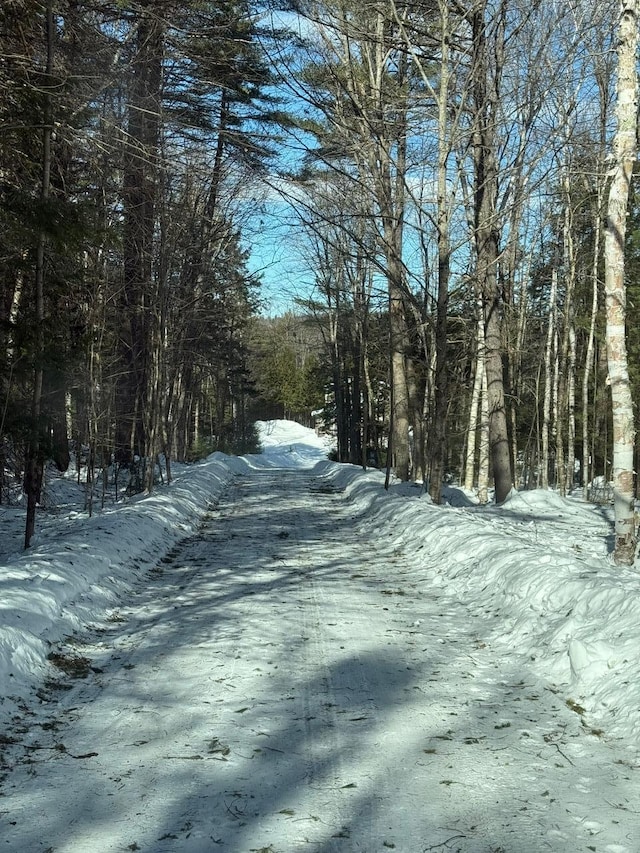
[{"x1": 0, "y1": 0, "x2": 640, "y2": 563}]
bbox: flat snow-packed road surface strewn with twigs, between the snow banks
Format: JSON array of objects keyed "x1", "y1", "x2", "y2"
[{"x1": 0, "y1": 468, "x2": 640, "y2": 853}]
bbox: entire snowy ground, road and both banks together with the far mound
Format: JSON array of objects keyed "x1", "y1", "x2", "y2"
[{"x1": 0, "y1": 421, "x2": 640, "y2": 853}]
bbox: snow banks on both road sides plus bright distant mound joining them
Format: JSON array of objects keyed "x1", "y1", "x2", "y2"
[{"x1": 0, "y1": 416, "x2": 640, "y2": 744}]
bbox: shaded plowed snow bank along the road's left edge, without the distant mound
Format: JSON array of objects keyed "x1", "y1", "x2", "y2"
[{"x1": 0, "y1": 454, "x2": 233, "y2": 723}]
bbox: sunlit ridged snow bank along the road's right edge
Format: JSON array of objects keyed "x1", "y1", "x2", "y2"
[{"x1": 310, "y1": 464, "x2": 640, "y2": 740}]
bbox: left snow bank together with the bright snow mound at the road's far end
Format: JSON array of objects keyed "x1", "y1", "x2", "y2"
[{"x1": 0, "y1": 422, "x2": 330, "y2": 726}]
